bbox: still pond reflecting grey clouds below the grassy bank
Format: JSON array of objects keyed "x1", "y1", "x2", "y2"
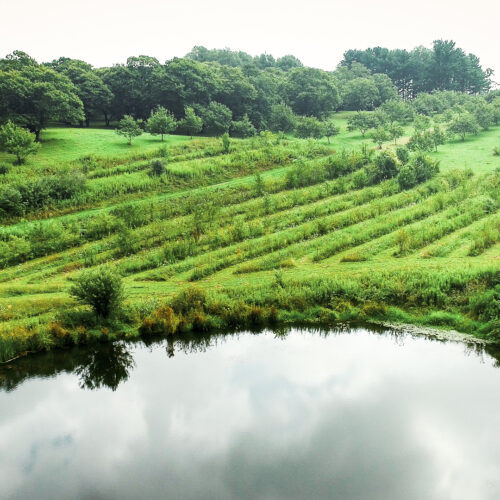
[{"x1": 0, "y1": 329, "x2": 500, "y2": 500}]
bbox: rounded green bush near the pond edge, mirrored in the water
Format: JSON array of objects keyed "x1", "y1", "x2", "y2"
[{"x1": 70, "y1": 267, "x2": 124, "y2": 318}]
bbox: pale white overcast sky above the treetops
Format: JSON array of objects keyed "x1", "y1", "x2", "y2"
[{"x1": 0, "y1": 0, "x2": 500, "y2": 81}]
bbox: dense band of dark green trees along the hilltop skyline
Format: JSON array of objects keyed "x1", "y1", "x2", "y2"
[{"x1": 0, "y1": 41, "x2": 491, "y2": 138}]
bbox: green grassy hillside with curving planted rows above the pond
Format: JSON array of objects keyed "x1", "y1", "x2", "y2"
[{"x1": 0, "y1": 123, "x2": 500, "y2": 361}]
